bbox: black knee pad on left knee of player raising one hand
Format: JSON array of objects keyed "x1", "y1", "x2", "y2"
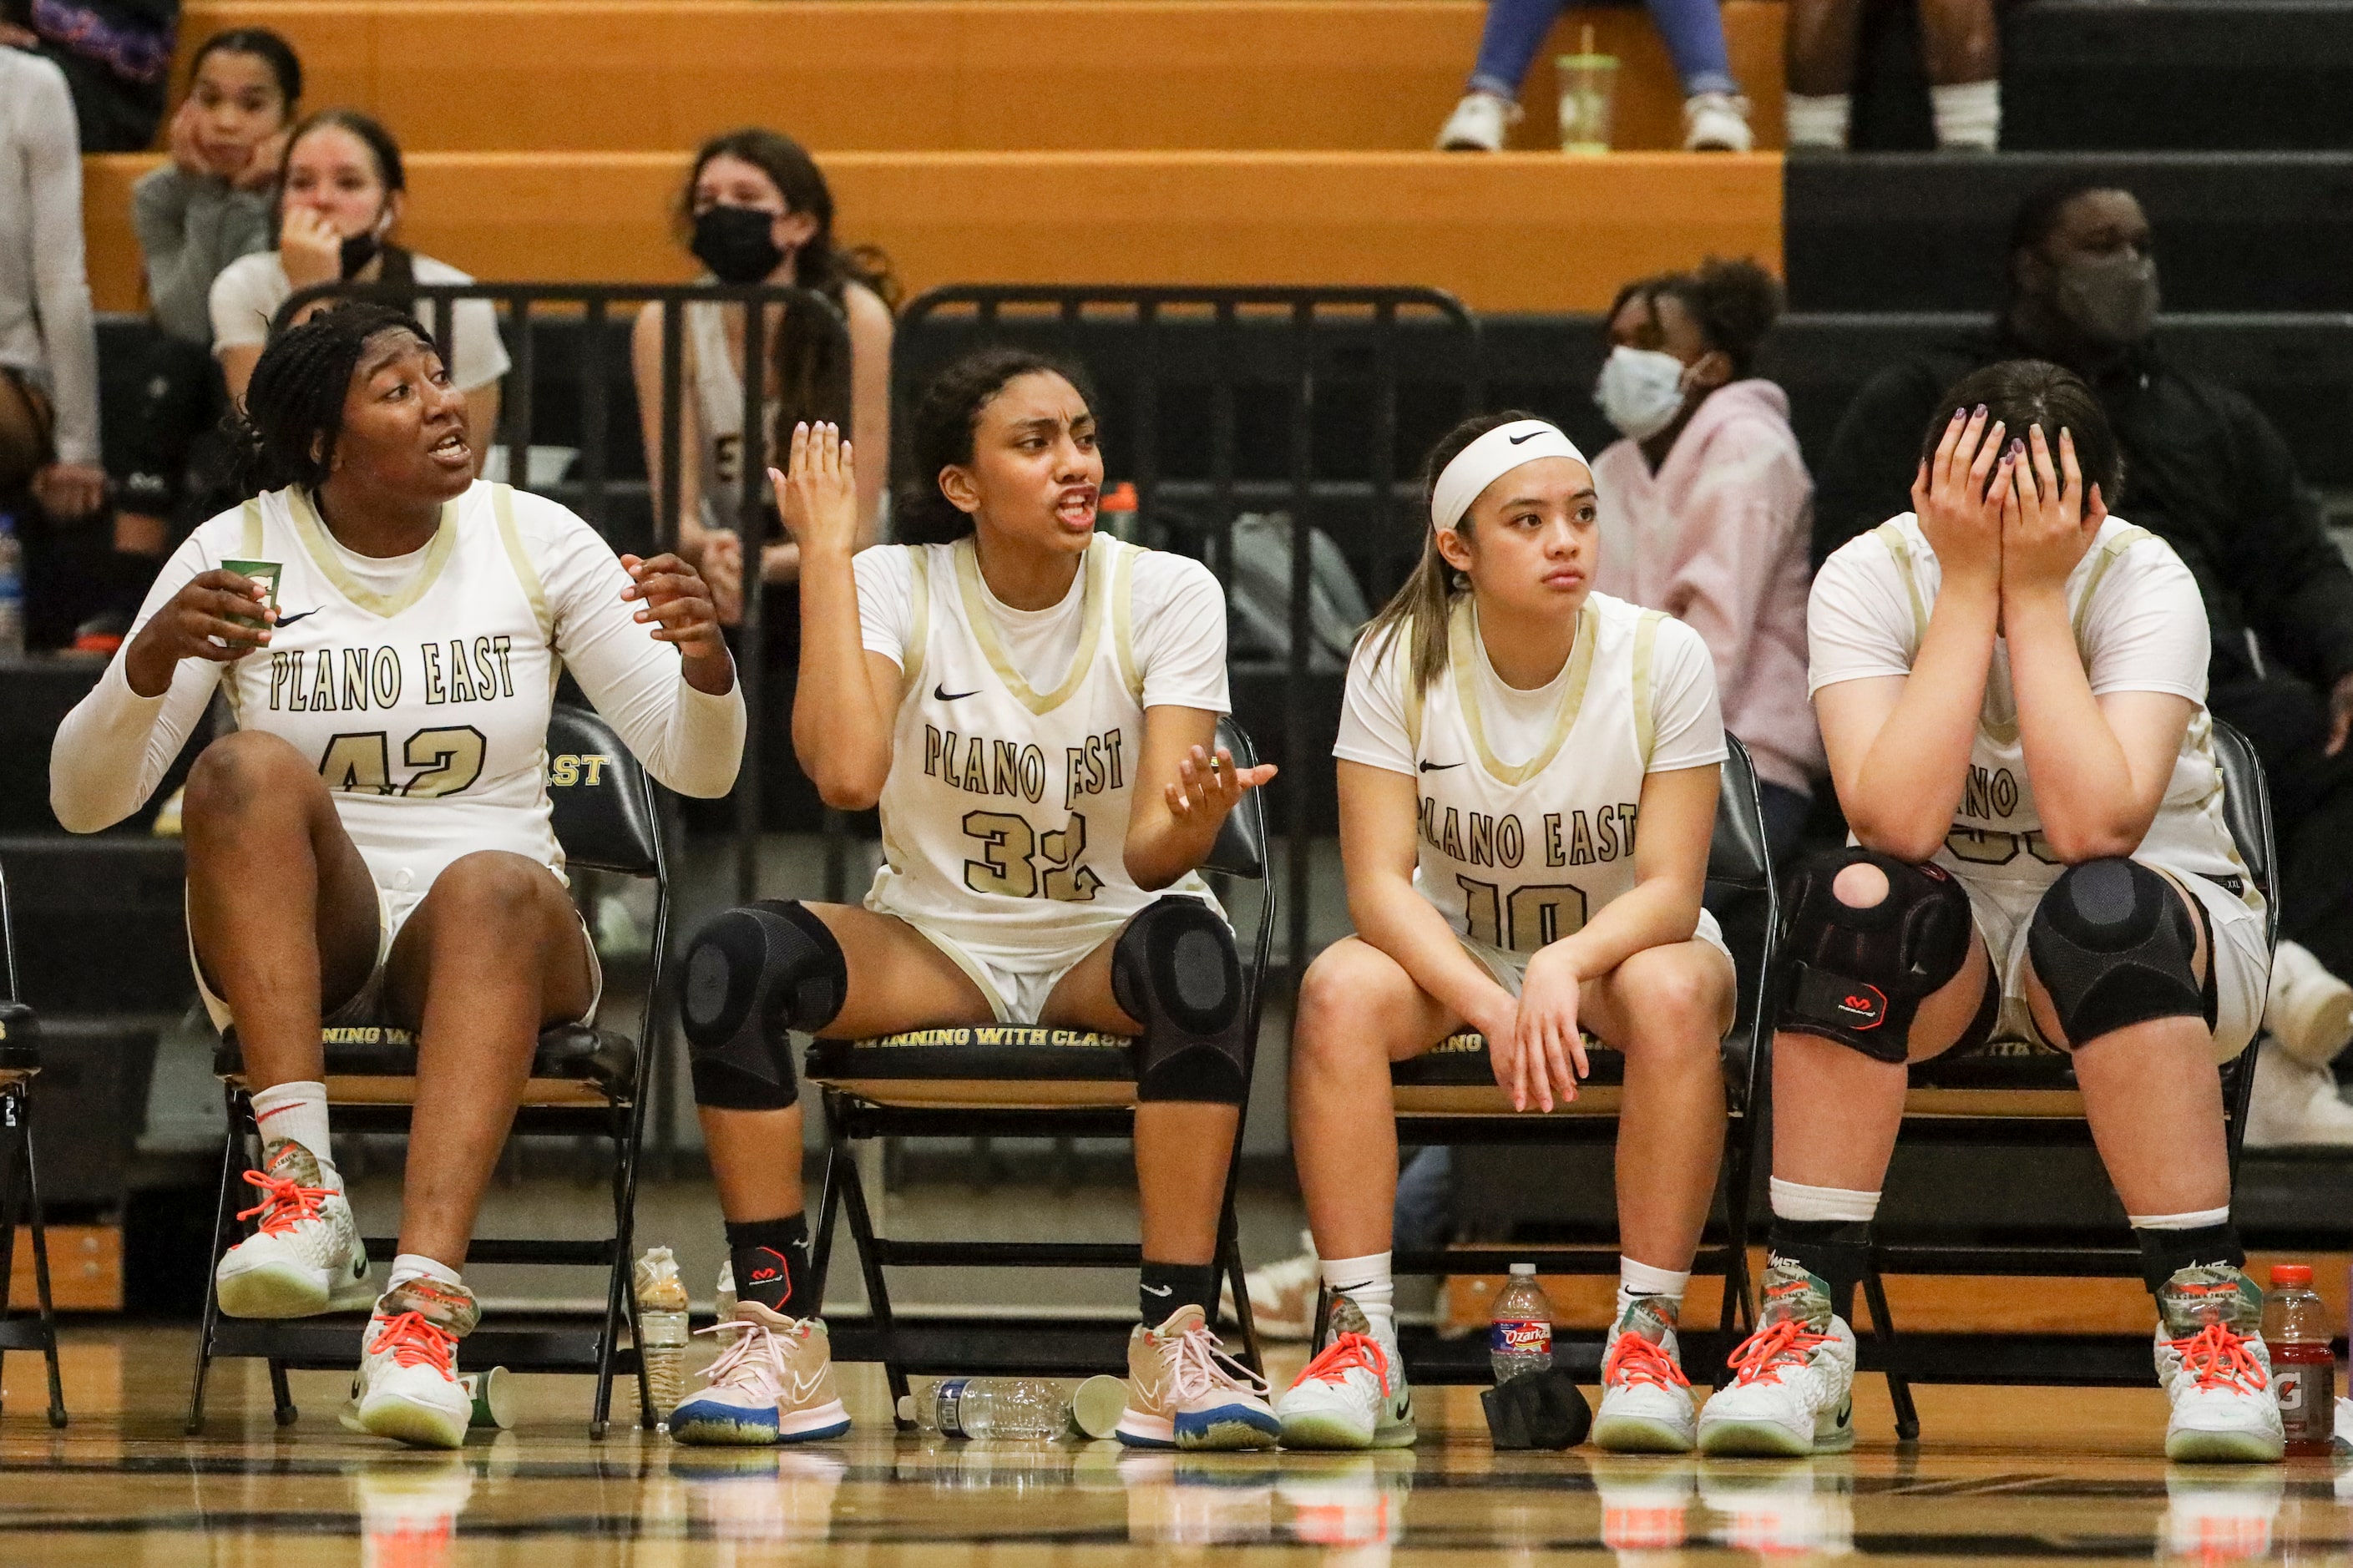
[{"x1": 678, "y1": 899, "x2": 849, "y2": 1111}]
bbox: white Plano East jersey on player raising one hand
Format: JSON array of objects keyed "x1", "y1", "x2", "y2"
[{"x1": 866, "y1": 534, "x2": 1214, "y2": 963}]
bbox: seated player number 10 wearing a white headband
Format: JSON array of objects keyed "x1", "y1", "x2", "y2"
[{"x1": 1280, "y1": 414, "x2": 1734, "y2": 1450}]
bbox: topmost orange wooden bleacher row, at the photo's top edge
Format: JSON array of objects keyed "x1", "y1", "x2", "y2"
[{"x1": 175, "y1": 0, "x2": 1781, "y2": 153}]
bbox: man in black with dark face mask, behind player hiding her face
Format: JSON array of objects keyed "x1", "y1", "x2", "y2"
[{"x1": 1814, "y1": 181, "x2": 2353, "y2": 1146}]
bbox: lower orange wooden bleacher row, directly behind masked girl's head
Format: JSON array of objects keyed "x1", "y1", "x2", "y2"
[{"x1": 83, "y1": 153, "x2": 1781, "y2": 311}]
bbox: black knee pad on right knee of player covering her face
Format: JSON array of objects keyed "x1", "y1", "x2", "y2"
[{"x1": 2026, "y1": 855, "x2": 2214, "y2": 1045}]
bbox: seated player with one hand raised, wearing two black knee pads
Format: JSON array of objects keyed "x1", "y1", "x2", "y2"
[{"x1": 670, "y1": 351, "x2": 1275, "y2": 1448}]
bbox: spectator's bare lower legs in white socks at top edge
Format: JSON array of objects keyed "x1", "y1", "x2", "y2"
[{"x1": 1784, "y1": 0, "x2": 2002, "y2": 150}]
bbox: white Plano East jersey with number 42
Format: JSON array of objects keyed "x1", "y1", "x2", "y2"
[{"x1": 221, "y1": 483, "x2": 563, "y2": 895}]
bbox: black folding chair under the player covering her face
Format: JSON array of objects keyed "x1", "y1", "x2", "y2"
[{"x1": 1859, "y1": 721, "x2": 2280, "y2": 1441}]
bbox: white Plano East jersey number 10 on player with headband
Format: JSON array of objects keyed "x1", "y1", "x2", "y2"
[{"x1": 1402, "y1": 594, "x2": 1703, "y2": 953}]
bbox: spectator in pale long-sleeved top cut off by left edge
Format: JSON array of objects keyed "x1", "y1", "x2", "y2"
[{"x1": 0, "y1": 47, "x2": 106, "y2": 520}]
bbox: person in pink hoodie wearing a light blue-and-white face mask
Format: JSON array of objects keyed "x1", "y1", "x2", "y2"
[{"x1": 1593, "y1": 256, "x2": 1821, "y2": 859}]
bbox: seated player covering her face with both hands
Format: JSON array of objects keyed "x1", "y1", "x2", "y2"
[{"x1": 1701, "y1": 360, "x2": 2280, "y2": 1459}]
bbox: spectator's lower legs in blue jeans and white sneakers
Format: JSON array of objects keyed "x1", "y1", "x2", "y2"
[{"x1": 1438, "y1": 0, "x2": 1755, "y2": 153}]
